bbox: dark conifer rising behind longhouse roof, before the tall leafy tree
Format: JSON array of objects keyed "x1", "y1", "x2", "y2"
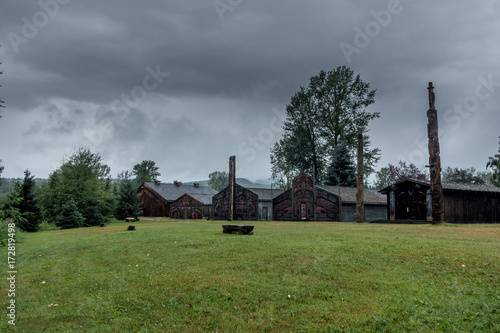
[{"x1": 325, "y1": 144, "x2": 357, "y2": 187}]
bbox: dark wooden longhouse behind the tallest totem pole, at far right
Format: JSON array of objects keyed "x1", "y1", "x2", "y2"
[{"x1": 380, "y1": 179, "x2": 500, "y2": 224}]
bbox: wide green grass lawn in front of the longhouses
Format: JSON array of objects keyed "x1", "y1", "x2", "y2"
[{"x1": 0, "y1": 220, "x2": 500, "y2": 332}]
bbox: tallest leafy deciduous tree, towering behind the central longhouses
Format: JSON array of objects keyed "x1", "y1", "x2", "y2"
[{"x1": 271, "y1": 66, "x2": 380, "y2": 186}]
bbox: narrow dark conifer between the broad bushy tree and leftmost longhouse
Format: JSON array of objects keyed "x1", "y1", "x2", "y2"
[{"x1": 115, "y1": 171, "x2": 142, "y2": 220}]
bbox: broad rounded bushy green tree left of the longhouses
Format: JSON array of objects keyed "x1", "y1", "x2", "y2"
[{"x1": 42, "y1": 148, "x2": 115, "y2": 226}]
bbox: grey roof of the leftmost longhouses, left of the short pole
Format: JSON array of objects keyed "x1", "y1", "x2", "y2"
[{"x1": 143, "y1": 183, "x2": 217, "y2": 205}]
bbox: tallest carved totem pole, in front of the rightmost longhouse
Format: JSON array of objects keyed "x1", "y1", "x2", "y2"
[{"x1": 427, "y1": 82, "x2": 444, "y2": 224}]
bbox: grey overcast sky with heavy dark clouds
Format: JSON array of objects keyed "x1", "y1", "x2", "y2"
[{"x1": 0, "y1": 0, "x2": 500, "y2": 182}]
